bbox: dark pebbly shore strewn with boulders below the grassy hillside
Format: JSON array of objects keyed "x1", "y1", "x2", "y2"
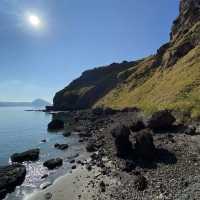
[{"x1": 0, "y1": 108, "x2": 200, "y2": 200}]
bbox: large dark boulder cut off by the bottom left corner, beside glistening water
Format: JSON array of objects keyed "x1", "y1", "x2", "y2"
[{"x1": 0, "y1": 164, "x2": 26, "y2": 199}]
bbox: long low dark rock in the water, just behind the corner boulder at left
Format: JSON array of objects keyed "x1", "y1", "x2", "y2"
[{"x1": 11, "y1": 149, "x2": 40, "y2": 163}]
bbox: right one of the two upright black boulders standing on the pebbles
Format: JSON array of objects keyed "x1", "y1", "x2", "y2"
[{"x1": 135, "y1": 129, "x2": 155, "y2": 160}]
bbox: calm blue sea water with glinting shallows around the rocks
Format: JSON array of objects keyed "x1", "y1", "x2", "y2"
[{"x1": 0, "y1": 107, "x2": 83, "y2": 200}]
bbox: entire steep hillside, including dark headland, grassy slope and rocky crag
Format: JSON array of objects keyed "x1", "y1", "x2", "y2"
[{"x1": 54, "y1": 0, "x2": 200, "y2": 117}]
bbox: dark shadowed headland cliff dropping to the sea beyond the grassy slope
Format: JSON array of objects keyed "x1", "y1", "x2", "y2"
[{"x1": 54, "y1": 61, "x2": 141, "y2": 110}]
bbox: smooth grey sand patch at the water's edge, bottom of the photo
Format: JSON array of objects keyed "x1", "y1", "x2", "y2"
[{"x1": 23, "y1": 166, "x2": 114, "y2": 200}]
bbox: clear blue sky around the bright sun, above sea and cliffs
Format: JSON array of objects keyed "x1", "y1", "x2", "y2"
[{"x1": 0, "y1": 0, "x2": 179, "y2": 102}]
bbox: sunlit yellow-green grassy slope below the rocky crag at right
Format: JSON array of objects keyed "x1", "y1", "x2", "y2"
[{"x1": 95, "y1": 46, "x2": 200, "y2": 115}]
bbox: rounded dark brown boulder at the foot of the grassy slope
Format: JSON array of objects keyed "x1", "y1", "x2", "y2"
[{"x1": 148, "y1": 110, "x2": 176, "y2": 130}]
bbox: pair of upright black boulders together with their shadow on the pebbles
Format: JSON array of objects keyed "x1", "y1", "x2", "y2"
[{"x1": 112, "y1": 125, "x2": 177, "y2": 172}]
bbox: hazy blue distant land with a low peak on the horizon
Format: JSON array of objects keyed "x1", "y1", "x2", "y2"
[{"x1": 0, "y1": 99, "x2": 51, "y2": 107}]
